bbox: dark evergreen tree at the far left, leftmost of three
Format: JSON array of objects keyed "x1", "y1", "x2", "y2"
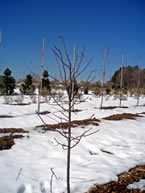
[{"x1": 3, "y1": 68, "x2": 16, "y2": 95}]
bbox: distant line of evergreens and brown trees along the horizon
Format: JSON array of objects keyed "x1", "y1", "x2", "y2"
[{"x1": 0, "y1": 66, "x2": 145, "y2": 96}]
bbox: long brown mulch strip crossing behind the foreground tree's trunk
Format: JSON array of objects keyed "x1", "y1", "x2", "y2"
[{"x1": 37, "y1": 118, "x2": 100, "y2": 131}]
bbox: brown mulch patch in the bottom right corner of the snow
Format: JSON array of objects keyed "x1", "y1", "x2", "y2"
[{"x1": 87, "y1": 165, "x2": 145, "y2": 193}]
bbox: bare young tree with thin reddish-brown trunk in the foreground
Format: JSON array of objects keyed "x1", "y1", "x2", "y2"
[{"x1": 46, "y1": 36, "x2": 97, "y2": 193}]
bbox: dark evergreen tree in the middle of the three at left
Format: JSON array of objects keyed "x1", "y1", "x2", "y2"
[{"x1": 20, "y1": 74, "x2": 35, "y2": 95}]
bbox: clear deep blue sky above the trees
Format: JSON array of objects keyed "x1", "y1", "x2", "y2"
[{"x1": 0, "y1": 0, "x2": 145, "y2": 78}]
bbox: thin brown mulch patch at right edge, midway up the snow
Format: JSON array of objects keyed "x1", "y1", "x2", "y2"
[{"x1": 103, "y1": 113, "x2": 143, "y2": 120}]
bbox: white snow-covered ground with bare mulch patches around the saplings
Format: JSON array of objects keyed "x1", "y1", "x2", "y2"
[{"x1": 0, "y1": 92, "x2": 145, "y2": 193}]
